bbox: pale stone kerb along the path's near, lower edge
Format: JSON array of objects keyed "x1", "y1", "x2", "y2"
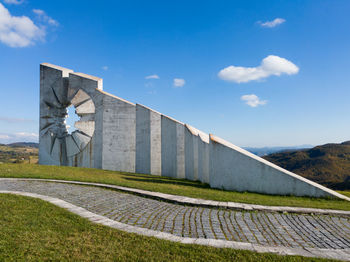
[{"x1": 0, "y1": 191, "x2": 350, "y2": 261}]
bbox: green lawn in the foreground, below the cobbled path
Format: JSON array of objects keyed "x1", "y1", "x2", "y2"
[{"x1": 0, "y1": 194, "x2": 334, "y2": 261}]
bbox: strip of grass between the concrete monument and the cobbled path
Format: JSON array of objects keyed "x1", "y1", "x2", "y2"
[{"x1": 0, "y1": 164, "x2": 350, "y2": 211}]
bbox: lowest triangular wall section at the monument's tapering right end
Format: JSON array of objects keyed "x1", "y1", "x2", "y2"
[{"x1": 210, "y1": 135, "x2": 348, "y2": 197}]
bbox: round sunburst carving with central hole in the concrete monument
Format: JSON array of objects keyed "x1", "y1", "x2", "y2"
[{"x1": 40, "y1": 89, "x2": 95, "y2": 164}]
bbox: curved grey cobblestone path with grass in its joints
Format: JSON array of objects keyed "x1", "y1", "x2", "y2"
[{"x1": 0, "y1": 179, "x2": 350, "y2": 259}]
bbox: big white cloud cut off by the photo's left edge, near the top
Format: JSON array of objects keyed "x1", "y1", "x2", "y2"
[{"x1": 0, "y1": 3, "x2": 45, "y2": 47}]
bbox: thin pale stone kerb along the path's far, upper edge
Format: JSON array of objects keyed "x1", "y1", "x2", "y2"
[{"x1": 0, "y1": 178, "x2": 350, "y2": 217}]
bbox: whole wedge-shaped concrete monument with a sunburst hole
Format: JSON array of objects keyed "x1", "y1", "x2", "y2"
[{"x1": 39, "y1": 63, "x2": 348, "y2": 198}]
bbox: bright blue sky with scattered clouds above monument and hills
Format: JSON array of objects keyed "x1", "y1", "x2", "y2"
[{"x1": 0, "y1": 0, "x2": 350, "y2": 147}]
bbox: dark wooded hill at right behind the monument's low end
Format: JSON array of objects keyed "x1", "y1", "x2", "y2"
[{"x1": 263, "y1": 141, "x2": 350, "y2": 190}]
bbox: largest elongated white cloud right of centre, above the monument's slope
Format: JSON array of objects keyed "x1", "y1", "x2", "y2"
[{"x1": 218, "y1": 55, "x2": 299, "y2": 83}]
